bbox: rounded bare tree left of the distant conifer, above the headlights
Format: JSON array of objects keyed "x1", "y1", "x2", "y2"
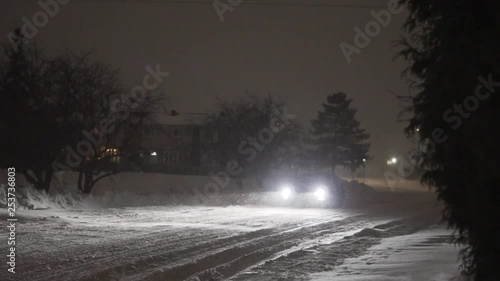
[{"x1": 202, "y1": 95, "x2": 298, "y2": 188}]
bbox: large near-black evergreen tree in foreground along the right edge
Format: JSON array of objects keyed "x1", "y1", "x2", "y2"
[{"x1": 401, "y1": 0, "x2": 500, "y2": 281}]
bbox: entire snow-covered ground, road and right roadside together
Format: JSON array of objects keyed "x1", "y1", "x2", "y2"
[{"x1": 0, "y1": 187, "x2": 468, "y2": 281}]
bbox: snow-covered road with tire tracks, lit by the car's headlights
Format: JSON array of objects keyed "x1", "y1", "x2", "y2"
[{"x1": 1, "y1": 192, "x2": 460, "y2": 281}]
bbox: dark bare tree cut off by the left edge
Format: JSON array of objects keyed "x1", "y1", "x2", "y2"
[{"x1": 0, "y1": 30, "x2": 63, "y2": 191}]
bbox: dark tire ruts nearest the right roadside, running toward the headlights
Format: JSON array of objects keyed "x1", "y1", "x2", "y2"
[{"x1": 114, "y1": 215, "x2": 376, "y2": 281}]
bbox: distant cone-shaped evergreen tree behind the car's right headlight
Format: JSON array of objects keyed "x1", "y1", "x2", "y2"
[{"x1": 311, "y1": 92, "x2": 370, "y2": 171}]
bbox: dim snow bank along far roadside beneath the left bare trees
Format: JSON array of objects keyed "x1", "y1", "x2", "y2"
[{"x1": 0, "y1": 170, "x2": 249, "y2": 209}]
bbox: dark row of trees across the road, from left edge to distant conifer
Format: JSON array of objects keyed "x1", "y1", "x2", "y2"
[{"x1": 0, "y1": 30, "x2": 369, "y2": 194}]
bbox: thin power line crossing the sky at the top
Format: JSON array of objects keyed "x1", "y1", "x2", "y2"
[{"x1": 76, "y1": 0, "x2": 387, "y2": 9}]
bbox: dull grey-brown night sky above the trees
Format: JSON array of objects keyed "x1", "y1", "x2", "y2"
[{"x1": 0, "y1": 0, "x2": 409, "y2": 177}]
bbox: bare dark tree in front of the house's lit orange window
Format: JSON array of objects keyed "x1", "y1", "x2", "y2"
[{"x1": 50, "y1": 53, "x2": 161, "y2": 193}]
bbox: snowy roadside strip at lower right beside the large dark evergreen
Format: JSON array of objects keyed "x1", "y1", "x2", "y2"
[{"x1": 311, "y1": 227, "x2": 467, "y2": 281}]
